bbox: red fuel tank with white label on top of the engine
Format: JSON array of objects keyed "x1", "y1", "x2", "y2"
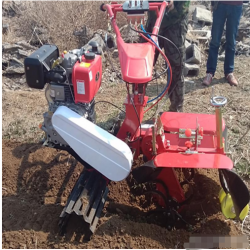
[{"x1": 72, "y1": 55, "x2": 102, "y2": 103}]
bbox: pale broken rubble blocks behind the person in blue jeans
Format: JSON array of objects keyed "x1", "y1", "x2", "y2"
[{"x1": 184, "y1": 1, "x2": 250, "y2": 76}]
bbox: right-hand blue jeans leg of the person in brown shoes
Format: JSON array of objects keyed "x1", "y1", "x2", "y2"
[{"x1": 224, "y1": 5, "x2": 242, "y2": 75}]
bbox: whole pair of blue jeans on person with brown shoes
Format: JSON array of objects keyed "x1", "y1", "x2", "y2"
[{"x1": 207, "y1": 3, "x2": 242, "y2": 75}]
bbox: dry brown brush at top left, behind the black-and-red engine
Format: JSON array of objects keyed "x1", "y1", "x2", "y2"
[{"x1": 3, "y1": 1, "x2": 129, "y2": 50}]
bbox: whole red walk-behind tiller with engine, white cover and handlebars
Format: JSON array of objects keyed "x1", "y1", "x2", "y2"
[{"x1": 25, "y1": 1, "x2": 249, "y2": 238}]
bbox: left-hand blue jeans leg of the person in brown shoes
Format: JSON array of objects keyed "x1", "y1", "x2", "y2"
[{"x1": 207, "y1": 4, "x2": 227, "y2": 75}]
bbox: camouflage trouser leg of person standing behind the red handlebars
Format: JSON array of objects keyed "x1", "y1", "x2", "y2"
[{"x1": 164, "y1": 15, "x2": 188, "y2": 112}]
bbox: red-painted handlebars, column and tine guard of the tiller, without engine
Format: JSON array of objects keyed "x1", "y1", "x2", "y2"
[{"x1": 104, "y1": 2, "x2": 233, "y2": 209}]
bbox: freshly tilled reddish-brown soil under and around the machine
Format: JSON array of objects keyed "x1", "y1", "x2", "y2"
[{"x1": 2, "y1": 140, "x2": 244, "y2": 248}]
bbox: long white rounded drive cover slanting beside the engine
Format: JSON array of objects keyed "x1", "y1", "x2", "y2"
[{"x1": 52, "y1": 106, "x2": 133, "y2": 181}]
